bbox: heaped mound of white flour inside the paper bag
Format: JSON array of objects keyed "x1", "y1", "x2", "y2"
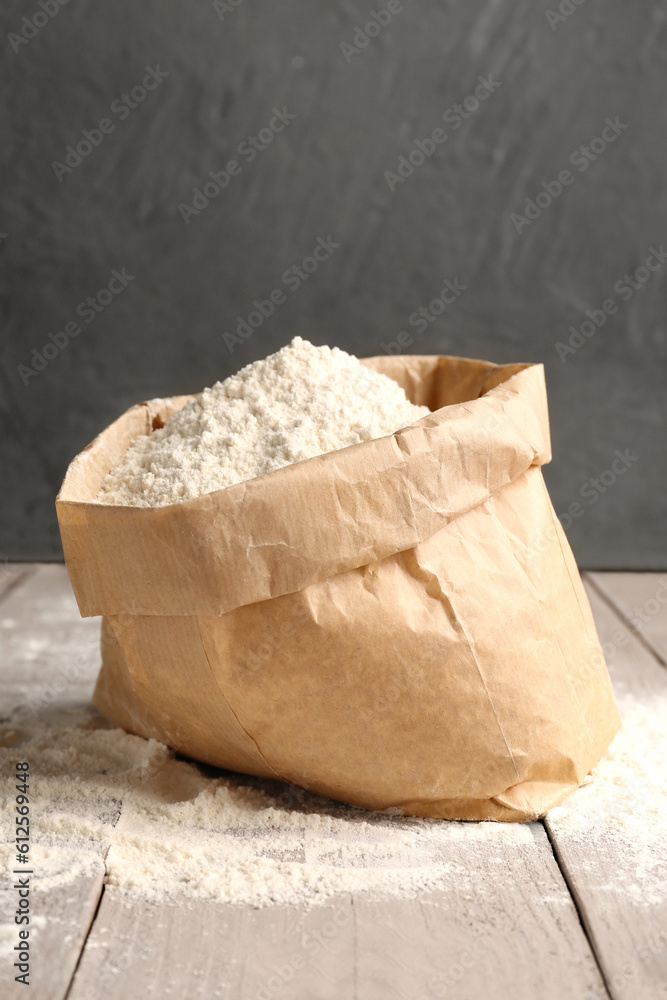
[{"x1": 99, "y1": 337, "x2": 429, "y2": 507}]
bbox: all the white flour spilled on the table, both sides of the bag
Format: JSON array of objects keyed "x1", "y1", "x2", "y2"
[{"x1": 0, "y1": 698, "x2": 667, "y2": 912}]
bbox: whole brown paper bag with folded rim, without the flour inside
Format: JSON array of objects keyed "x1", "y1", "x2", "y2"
[{"x1": 57, "y1": 357, "x2": 619, "y2": 820}]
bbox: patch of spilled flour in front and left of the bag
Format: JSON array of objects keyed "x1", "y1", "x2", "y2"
[{"x1": 0, "y1": 710, "x2": 533, "y2": 906}]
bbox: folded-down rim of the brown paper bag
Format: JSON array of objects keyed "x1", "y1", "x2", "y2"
[{"x1": 56, "y1": 355, "x2": 551, "y2": 616}]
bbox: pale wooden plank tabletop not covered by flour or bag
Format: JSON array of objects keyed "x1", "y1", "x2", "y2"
[{"x1": 0, "y1": 565, "x2": 667, "y2": 1000}]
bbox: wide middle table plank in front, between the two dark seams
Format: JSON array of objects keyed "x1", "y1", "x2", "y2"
[{"x1": 70, "y1": 823, "x2": 606, "y2": 1000}]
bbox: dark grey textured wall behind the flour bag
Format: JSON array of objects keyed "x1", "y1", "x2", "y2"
[{"x1": 0, "y1": 0, "x2": 667, "y2": 568}]
